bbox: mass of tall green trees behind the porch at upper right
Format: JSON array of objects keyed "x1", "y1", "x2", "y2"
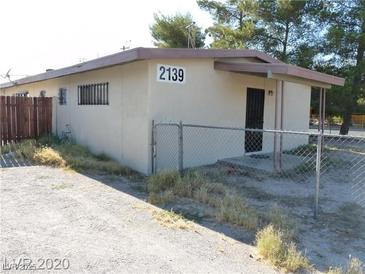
[{"x1": 197, "y1": 0, "x2": 365, "y2": 134}]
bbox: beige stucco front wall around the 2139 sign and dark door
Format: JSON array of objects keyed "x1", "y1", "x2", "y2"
[{"x1": 145, "y1": 59, "x2": 310, "y2": 172}]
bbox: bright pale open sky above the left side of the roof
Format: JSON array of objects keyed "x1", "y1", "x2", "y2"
[{"x1": 0, "y1": 0, "x2": 211, "y2": 82}]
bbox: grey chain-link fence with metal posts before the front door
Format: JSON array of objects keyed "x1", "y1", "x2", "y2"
[{"x1": 152, "y1": 123, "x2": 365, "y2": 214}]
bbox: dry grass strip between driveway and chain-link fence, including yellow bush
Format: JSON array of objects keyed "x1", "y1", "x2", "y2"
[{"x1": 147, "y1": 171, "x2": 310, "y2": 272}]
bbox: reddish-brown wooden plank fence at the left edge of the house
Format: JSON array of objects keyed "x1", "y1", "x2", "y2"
[{"x1": 0, "y1": 96, "x2": 52, "y2": 146}]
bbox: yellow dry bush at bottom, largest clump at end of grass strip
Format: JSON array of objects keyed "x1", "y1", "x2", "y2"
[{"x1": 256, "y1": 225, "x2": 309, "y2": 272}]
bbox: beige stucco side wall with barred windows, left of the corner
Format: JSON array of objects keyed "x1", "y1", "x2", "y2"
[{"x1": 1, "y1": 61, "x2": 149, "y2": 173}]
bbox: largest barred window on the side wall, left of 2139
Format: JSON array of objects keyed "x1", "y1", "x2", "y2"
[{"x1": 77, "y1": 83, "x2": 109, "y2": 105}]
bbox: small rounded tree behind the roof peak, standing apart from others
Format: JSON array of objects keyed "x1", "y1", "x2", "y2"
[{"x1": 150, "y1": 14, "x2": 205, "y2": 48}]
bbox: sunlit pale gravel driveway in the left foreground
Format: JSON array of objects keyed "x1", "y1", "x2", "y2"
[{"x1": 0, "y1": 166, "x2": 276, "y2": 273}]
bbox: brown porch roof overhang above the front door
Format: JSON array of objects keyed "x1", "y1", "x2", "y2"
[{"x1": 214, "y1": 61, "x2": 345, "y2": 88}]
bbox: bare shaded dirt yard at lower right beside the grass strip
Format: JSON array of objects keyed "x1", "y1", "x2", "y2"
[{"x1": 196, "y1": 161, "x2": 365, "y2": 271}]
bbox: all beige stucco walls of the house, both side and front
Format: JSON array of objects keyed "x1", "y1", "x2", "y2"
[{"x1": 0, "y1": 59, "x2": 310, "y2": 176}]
